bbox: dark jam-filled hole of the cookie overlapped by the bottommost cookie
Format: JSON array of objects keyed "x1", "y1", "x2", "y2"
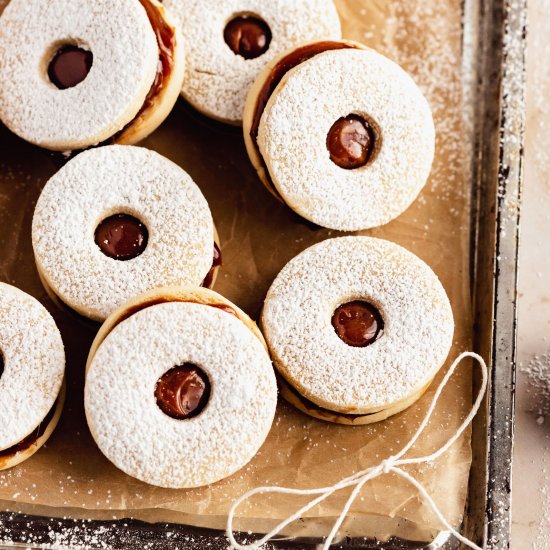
[{"x1": 95, "y1": 214, "x2": 149, "y2": 261}]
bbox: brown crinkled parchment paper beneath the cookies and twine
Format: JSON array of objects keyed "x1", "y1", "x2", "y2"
[{"x1": 0, "y1": 0, "x2": 471, "y2": 540}]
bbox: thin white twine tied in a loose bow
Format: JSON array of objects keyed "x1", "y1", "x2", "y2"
[{"x1": 226, "y1": 351, "x2": 488, "y2": 550}]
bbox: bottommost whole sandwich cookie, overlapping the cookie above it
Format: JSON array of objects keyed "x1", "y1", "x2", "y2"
[{"x1": 84, "y1": 288, "x2": 277, "y2": 488}]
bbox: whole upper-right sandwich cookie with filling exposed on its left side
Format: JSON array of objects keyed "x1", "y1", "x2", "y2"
[{"x1": 243, "y1": 41, "x2": 435, "y2": 231}]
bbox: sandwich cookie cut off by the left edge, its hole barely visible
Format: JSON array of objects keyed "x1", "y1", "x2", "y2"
[{"x1": 0, "y1": 283, "x2": 65, "y2": 470}]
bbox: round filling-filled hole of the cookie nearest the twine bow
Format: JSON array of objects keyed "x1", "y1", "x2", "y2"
[{"x1": 332, "y1": 300, "x2": 384, "y2": 348}]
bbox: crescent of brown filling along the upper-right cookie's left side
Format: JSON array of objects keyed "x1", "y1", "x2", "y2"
[{"x1": 250, "y1": 40, "x2": 357, "y2": 200}]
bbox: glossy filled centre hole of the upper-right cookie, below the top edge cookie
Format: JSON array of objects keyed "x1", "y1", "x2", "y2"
[{"x1": 327, "y1": 113, "x2": 380, "y2": 170}]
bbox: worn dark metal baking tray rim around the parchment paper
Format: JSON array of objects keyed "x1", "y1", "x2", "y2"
[{"x1": 0, "y1": 0, "x2": 526, "y2": 550}]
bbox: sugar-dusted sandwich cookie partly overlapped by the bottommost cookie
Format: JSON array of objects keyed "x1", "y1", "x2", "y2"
[{"x1": 32, "y1": 145, "x2": 220, "y2": 321}]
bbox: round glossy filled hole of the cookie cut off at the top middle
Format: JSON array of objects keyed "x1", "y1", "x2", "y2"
[{"x1": 223, "y1": 13, "x2": 272, "y2": 59}]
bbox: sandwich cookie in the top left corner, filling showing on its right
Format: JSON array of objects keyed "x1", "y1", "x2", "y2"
[{"x1": 0, "y1": 0, "x2": 185, "y2": 151}]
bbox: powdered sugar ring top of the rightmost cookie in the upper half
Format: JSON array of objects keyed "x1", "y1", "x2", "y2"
[{"x1": 258, "y1": 49, "x2": 435, "y2": 231}]
